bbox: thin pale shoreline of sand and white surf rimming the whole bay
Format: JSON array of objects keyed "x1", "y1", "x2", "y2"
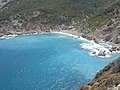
[{"x1": 0, "y1": 30, "x2": 120, "y2": 58}]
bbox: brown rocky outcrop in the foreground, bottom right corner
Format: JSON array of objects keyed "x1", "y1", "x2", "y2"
[{"x1": 80, "y1": 58, "x2": 120, "y2": 90}]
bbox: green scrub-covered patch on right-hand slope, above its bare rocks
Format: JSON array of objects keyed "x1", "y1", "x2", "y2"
[{"x1": 88, "y1": 0, "x2": 120, "y2": 27}]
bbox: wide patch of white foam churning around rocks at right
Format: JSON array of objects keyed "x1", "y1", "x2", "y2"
[{"x1": 80, "y1": 41, "x2": 120, "y2": 58}]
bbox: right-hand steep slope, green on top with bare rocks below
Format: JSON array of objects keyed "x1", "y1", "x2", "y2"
[{"x1": 78, "y1": 0, "x2": 120, "y2": 44}]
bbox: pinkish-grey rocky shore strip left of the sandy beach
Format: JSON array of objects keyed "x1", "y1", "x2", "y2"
[{"x1": 0, "y1": 26, "x2": 60, "y2": 37}]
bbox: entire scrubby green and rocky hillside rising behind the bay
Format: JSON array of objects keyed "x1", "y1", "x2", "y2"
[{"x1": 0, "y1": 0, "x2": 120, "y2": 44}]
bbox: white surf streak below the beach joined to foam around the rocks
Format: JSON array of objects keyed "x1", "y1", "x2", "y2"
[{"x1": 52, "y1": 32, "x2": 112, "y2": 58}]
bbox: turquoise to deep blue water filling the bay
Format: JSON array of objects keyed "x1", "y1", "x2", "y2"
[{"x1": 0, "y1": 34, "x2": 118, "y2": 90}]
